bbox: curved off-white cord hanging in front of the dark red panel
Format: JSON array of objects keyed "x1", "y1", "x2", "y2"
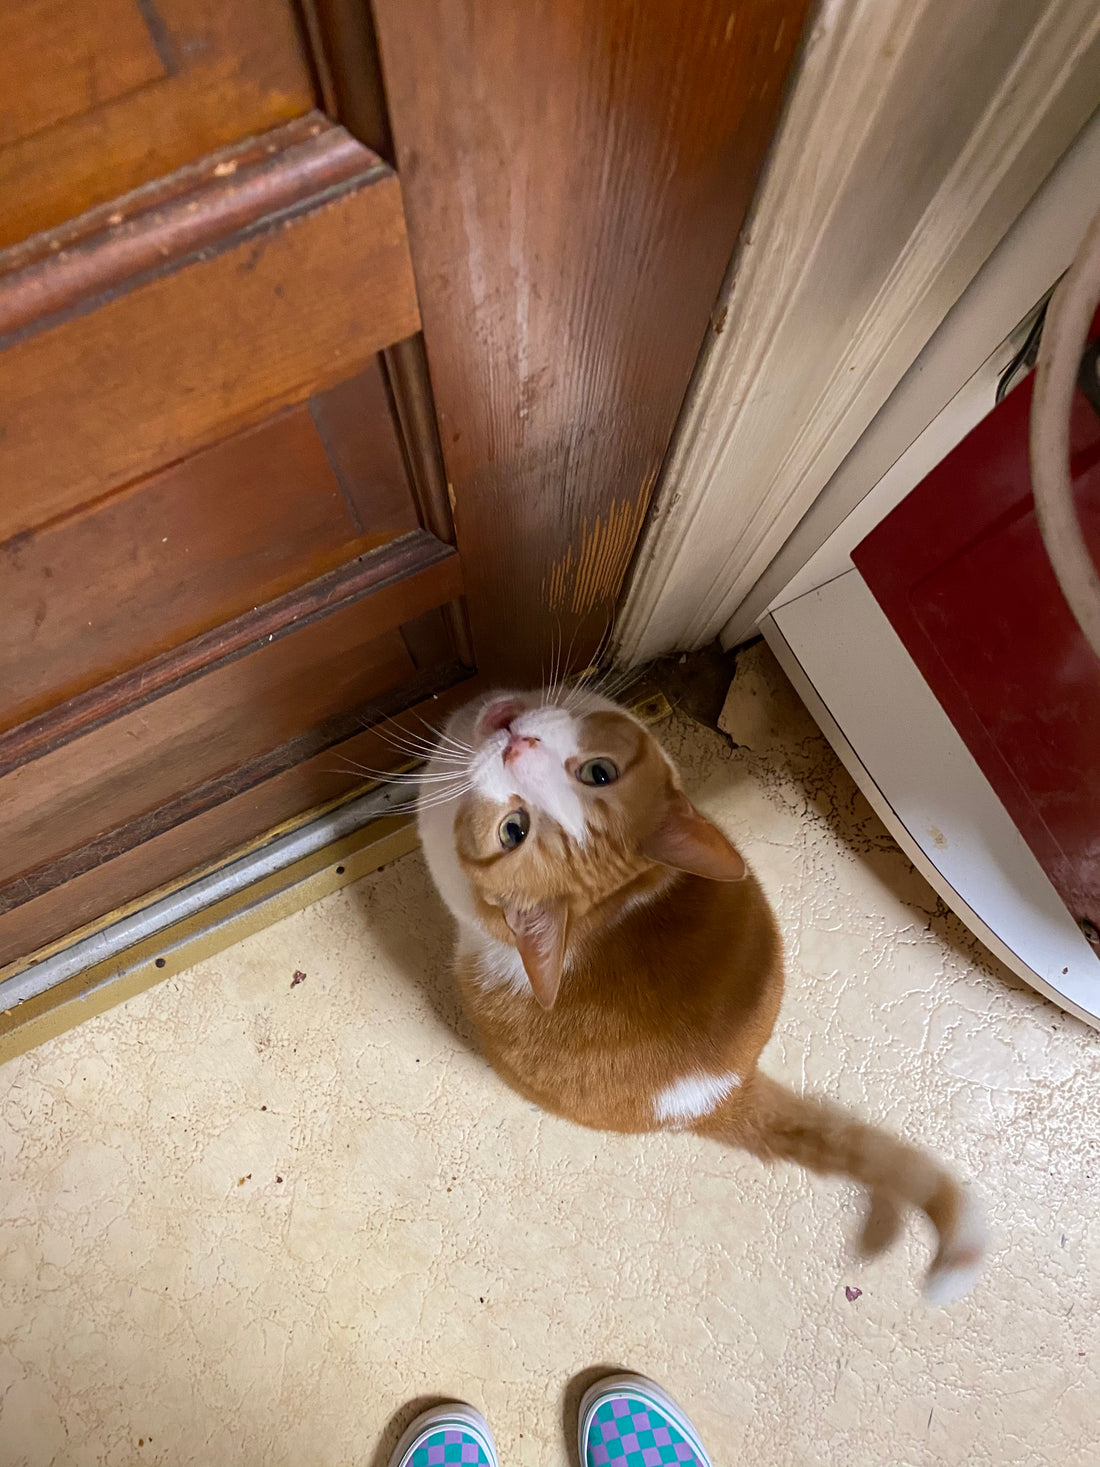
[{"x1": 1030, "y1": 199, "x2": 1100, "y2": 657}]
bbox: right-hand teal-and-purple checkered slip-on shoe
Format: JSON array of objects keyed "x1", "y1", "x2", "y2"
[{"x1": 576, "y1": 1375, "x2": 711, "y2": 1467}]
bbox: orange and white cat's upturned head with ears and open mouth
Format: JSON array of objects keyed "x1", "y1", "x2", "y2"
[{"x1": 419, "y1": 689, "x2": 745, "y2": 1008}]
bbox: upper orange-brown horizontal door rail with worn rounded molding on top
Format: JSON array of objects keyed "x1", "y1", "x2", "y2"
[{"x1": 0, "y1": 122, "x2": 419, "y2": 540}]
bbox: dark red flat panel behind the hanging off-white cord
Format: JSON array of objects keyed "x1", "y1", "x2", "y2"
[{"x1": 852, "y1": 317, "x2": 1100, "y2": 949}]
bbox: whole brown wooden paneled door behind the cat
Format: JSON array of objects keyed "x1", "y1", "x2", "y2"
[{"x1": 0, "y1": 0, "x2": 805, "y2": 971}]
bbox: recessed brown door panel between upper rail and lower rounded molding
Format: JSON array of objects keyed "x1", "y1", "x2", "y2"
[{"x1": 0, "y1": 359, "x2": 418, "y2": 731}]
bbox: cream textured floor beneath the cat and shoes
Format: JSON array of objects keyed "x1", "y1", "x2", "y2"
[{"x1": 0, "y1": 647, "x2": 1100, "y2": 1467}]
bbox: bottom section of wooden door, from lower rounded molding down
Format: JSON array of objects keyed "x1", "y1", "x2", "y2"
[{"x1": 0, "y1": 531, "x2": 462, "y2": 938}]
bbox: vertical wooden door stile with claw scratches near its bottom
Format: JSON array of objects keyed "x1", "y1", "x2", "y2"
[{"x1": 374, "y1": 0, "x2": 807, "y2": 681}]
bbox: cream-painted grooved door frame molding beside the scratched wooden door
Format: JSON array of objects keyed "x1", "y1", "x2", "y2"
[{"x1": 615, "y1": 0, "x2": 1100, "y2": 665}]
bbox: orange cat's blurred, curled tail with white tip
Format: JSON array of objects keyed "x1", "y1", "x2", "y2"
[{"x1": 698, "y1": 1072, "x2": 987, "y2": 1304}]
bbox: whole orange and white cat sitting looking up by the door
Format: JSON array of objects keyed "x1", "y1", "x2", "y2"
[{"x1": 418, "y1": 689, "x2": 984, "y2": 1303}]
